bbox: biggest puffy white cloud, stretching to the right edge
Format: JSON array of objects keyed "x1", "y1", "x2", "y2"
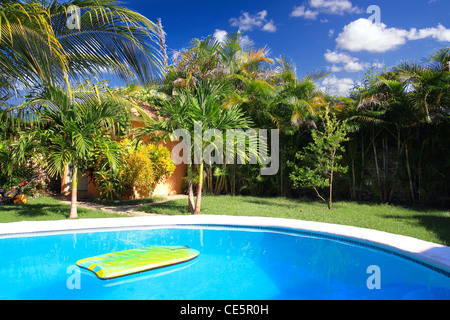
[{"x1": 336, "y1": 18, "x2": 450, "y2": 52}]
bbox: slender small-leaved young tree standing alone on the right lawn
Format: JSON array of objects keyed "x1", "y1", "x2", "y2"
[{"x1": 289, "y1": 110, "x2": 348, "y2": 210}]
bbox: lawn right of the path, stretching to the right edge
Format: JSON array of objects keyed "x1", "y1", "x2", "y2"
[{"x1": 139, "y1": 196, "x2": 450, "y2": 246}]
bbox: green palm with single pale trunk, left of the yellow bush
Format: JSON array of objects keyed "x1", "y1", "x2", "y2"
[{"x1": 29, "y1": 84, "x2": 127, "y2": 218}]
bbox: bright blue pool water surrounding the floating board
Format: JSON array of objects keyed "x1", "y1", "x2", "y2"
[{"x1": 0, "y1": 227, "x2": 450, "y2": 299}]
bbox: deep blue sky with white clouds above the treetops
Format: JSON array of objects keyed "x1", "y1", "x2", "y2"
[{"x1": 124, "y1": 0, "x2": 450, "y2": 94}]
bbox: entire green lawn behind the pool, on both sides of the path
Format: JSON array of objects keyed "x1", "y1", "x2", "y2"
[{"x1": 0, "y1": 196, "x2": 450, "y2": 246}]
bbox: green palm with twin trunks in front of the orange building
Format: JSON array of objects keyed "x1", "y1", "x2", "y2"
[{"x1": 148, "y1": 79, "x2": 251, "y2": 214}]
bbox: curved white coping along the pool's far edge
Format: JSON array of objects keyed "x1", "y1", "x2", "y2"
[{"x1": 0, "y1": 215, "x2": 450, "y2": 272}]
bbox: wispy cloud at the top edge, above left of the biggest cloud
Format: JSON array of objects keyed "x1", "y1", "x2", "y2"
[{"x1": 290, "y1": 0, "x2": 363, "y2": 20}]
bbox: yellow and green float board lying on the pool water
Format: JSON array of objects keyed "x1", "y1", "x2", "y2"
[{"x1": 77, "y1": 246, "x2": 199, "y2": 280}]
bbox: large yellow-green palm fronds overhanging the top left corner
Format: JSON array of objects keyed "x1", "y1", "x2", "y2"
[{"x1": 0, "y1": 0, "x2": 163, "y2": 126}]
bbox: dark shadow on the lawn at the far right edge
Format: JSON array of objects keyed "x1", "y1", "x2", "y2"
[{"x1": 383, "y1": 214, "x2": 450, "y2": 246}]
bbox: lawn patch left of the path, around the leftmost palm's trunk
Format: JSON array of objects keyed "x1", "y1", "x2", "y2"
[{"x1": 0, "y1": 197, "x2": 123, "y2": 223}]
